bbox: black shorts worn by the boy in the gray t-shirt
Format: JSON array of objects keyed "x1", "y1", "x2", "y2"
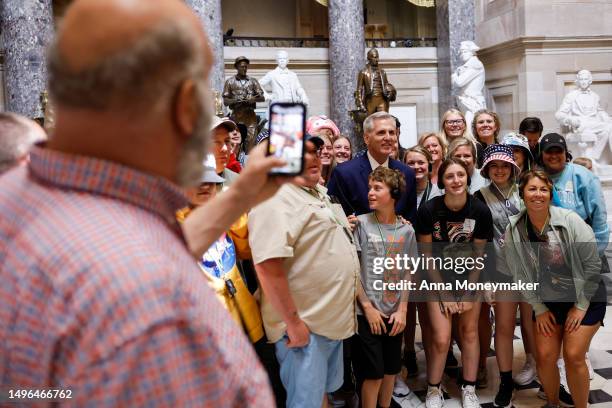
[{"x1": 351, "y1": 315, "x2": 403, "y2": 380}]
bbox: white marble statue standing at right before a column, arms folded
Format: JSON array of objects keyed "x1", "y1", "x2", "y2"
[{"x1": 451, "y1": 41, "x2": 486, "y2": 129}]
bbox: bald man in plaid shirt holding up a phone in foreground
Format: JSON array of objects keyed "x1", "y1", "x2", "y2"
[{"x1": 0, "y1": 0, "x2": 283, "y2": 408}]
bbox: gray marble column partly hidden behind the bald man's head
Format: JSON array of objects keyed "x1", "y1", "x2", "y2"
[{"x1": 186, "y1": 0, "x2": 225, "y2": 92}]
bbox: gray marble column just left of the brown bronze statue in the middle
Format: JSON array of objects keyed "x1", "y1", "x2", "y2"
[{"x1": 330, "y1": 0, "x2": 365, "y2": 146}]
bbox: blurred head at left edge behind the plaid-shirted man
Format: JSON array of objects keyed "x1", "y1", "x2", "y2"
[{"x1": 0, "y1": 112, "x2": 47, "y2": 174}]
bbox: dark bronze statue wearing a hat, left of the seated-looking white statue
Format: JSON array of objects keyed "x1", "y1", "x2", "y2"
[{"x1": 223, "y1": 57, "x2": 264, "y2": 149}]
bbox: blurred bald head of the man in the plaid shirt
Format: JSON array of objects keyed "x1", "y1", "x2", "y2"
[{"x1": 49, "y1": 0, "x2": 212, "y2": 185}]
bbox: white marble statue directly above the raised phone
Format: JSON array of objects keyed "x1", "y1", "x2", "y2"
[{"x1": 259, "y1": 50, "x2": 308, "y2": 105}]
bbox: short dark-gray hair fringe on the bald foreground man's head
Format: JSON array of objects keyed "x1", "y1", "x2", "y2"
[{"x1": 48, "y1": 19, "x2": 206, "y2": 113}]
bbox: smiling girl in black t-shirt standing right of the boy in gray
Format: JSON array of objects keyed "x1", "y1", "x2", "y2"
[{"x1": 415, "y1": 158, "x2": 493, "y2": 407}]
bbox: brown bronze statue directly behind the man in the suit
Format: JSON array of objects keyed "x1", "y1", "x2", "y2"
[{"x1": 355, "y1": 48, "x2": 397, "y2": 117}]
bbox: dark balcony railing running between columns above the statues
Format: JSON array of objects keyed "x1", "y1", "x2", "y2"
[{"x1": 223, "y1": 36, "x2": 437, "y2": 48}]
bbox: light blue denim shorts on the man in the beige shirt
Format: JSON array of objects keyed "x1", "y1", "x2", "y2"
[{"x1": 275, "y1": 333, "x2": 344, "y2": 408}]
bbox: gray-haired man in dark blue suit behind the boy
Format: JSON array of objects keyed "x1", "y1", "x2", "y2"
[{"x1": 328, "y1": 112, "x2": 416, "y2": 224}]
